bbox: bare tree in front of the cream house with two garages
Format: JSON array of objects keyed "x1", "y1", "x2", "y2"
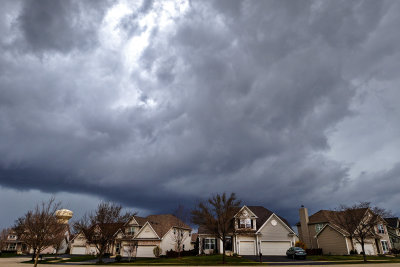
[{"x1": 192, "y1": 193, "x2": 241, "y2": 264}]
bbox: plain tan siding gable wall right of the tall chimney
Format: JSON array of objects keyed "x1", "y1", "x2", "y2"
[{"x1": 318, "y1": 227, "x2": 349, "y2": 255}]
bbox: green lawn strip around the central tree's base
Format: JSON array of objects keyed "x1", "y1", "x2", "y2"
[{"x1": 109, "y1": 255, "x2": 260, "y2": 266}]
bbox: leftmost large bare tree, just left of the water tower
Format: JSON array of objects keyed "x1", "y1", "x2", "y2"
[{"x1": 14, "y1": 197, "x2": 64, "y2": 267}]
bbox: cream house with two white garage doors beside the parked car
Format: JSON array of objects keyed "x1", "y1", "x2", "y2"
[{"x1": 198, "y1": 206, "x2": 297, "y2": 255}]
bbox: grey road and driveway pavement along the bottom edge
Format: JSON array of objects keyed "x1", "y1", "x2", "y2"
[{"x1": 0, "y1": 256, "x2": 400, "y2": 267}]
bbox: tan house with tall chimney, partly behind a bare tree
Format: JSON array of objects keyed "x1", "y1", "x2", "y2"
[{"x1": 297, "y1": 206, "x2": 391, "y2": 255}]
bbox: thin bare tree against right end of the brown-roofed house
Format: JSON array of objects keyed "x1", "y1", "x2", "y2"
[{"x1": 172, "y1": 205, "x2": 191, "y2": 258}]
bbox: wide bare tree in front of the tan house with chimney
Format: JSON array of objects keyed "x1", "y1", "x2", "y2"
[{"x1": 330, "y1": 202, "x2": 391, "y2": 262}]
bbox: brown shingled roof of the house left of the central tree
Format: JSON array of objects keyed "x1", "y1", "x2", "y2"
[{"x1": 145, "y1": 214, "x2": 191, "y2": 238}]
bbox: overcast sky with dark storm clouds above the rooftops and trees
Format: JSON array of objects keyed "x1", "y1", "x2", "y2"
[{"x1": 0, "y1": 0, "x2": 400, "y2": 227}]
